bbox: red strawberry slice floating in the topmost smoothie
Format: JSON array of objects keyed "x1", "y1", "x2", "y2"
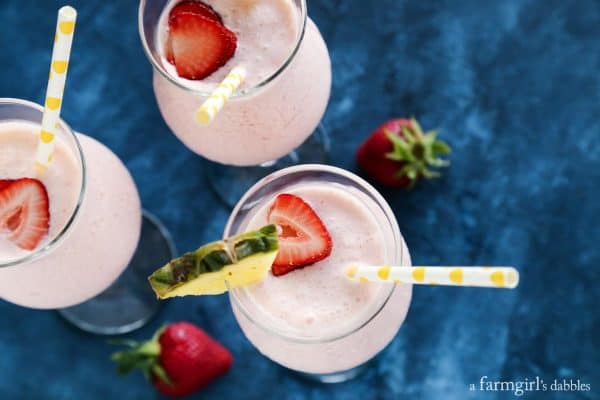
[{"x1": 169, "y1": 12, "x2": 237, "y2": 80}]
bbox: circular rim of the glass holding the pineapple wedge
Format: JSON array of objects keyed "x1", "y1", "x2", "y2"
[{"x1": 223, "y1": 164, "x2": 403, "y2": 344}]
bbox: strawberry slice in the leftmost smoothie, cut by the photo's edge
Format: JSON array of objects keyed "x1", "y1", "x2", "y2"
[{"x1": 0, "y1": 178, "x2": 50, "y2": 250}]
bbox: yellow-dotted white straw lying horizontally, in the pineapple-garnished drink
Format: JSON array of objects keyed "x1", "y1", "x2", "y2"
[{"x1": 346, "y1": 265, "x2": 519, "y2": 289}]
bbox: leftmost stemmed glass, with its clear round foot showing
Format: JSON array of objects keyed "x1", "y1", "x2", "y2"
[{"x1": 0, "y1": 99, "x2": 175, "y2": 334}]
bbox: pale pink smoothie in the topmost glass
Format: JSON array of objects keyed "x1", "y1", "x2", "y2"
[{"x1": 142, "y1": 0, "x2": 331, "y2": 166}]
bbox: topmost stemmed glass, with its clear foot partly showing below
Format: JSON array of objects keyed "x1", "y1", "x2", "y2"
[{"x1": 138, "y1": 0, "x2": 331, "y2": 206}]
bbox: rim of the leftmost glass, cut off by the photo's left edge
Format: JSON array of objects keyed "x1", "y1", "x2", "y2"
[{"x1": 0, "y1": 97, "x2": 87, "y2": 268}]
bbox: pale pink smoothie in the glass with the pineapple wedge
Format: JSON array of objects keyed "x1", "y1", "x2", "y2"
[{"x1": 227, "y1": 168, "x2": 412, "y2": 374}]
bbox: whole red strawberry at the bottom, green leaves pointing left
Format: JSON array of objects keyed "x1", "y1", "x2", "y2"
[{"x1": 111, "y1": 322, "x2": 233, "y2": 396}]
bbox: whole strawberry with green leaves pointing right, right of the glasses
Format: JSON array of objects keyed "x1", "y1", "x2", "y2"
[{"x1": 356, "y1": 118, "x2": 450, "y2": 187}]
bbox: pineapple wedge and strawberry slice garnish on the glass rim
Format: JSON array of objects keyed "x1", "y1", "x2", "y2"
[{"x1": 148, "y1": 193, "x2": 332, "y2": 299}]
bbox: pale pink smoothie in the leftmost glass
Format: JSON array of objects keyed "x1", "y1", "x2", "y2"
[{"x1": 0, "y1": 106, "x2": 141, "y2": 309}]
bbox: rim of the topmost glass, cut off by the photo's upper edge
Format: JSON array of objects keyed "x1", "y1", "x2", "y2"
[{"x1": 138, "y1": 0, "x2": 308, "y2": 100}]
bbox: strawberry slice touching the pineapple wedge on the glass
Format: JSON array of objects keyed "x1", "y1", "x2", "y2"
[{"x1": 268, "y1": 193, "x2": 332, "y2": 276}]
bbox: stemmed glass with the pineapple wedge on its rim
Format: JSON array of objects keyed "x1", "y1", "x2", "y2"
[{"x1": 223, "y1": 165, "x2": 412, "y2": 382}]
